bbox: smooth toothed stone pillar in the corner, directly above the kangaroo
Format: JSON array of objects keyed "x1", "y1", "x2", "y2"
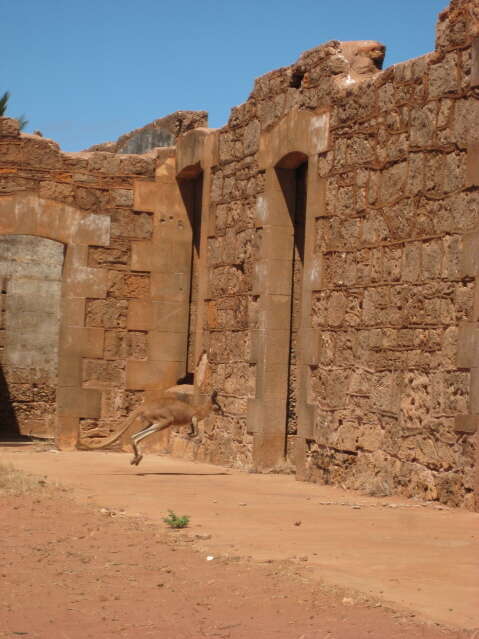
[{"x1": 127, "y1": 150, "x2": 192, "y2": 391}]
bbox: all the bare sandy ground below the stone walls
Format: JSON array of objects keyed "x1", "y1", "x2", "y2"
[{"x1": 0, "y1": 446, "x2": 479, "y2": 639}]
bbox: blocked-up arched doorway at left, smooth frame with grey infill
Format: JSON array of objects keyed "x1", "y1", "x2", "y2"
[{"x1": 0, "y1": 192, "x2": 110, "y2": 448}]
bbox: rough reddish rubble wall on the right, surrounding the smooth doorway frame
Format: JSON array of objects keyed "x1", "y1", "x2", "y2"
[{"x1": 184, "y1": 1, "x2": 479, "y2": 508}]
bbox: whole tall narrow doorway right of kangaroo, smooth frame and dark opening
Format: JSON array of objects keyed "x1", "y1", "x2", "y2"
[{"x1": 248, "y1": 111, "x2": 329, "y2": 475}]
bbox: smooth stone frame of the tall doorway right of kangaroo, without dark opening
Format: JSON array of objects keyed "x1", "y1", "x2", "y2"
[{"x1": 247, "y1": 111, "x2": 329, "y2": 478}]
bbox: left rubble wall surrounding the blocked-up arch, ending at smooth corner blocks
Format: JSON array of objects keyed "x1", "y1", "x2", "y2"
[{"x1": 0, "y1": 118, "x2": 155, "y2": 444}]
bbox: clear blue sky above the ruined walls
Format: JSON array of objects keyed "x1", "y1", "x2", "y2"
[{"x1": 0, "y1": 0, "x2": 448, "y2": 151}]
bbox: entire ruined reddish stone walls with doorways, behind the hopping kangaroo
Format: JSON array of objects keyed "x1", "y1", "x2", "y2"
[{"x1": 0, "y1": 0, "x2": 479, "y2": 510}]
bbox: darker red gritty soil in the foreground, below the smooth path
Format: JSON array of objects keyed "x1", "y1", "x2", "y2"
[{"x1": 0, "y1": 480, "x2": 476, "y2": 639}]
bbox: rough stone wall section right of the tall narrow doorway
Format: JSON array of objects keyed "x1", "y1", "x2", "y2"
[{"x1": 308, "y1": 52, "x2": 479, "y2": 505}]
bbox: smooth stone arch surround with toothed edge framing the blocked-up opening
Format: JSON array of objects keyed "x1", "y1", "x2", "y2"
[{"x1": 0, "y1": 193, "x2": 110, "y2": 448}]
